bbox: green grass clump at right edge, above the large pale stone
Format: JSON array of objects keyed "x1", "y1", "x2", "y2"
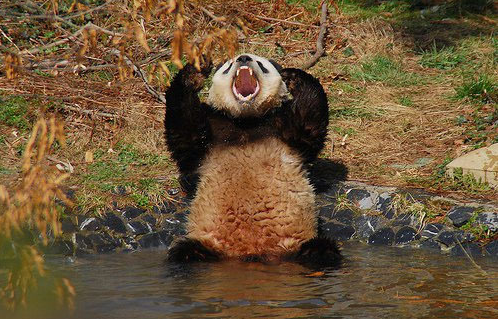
[{"x1": 455, "y1": 74, "x2": 498, "y2": 103}]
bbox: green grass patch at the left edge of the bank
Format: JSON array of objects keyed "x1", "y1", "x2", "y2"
[{"x1": 0, "y1": 96, "x2": 31, "y2": 131}]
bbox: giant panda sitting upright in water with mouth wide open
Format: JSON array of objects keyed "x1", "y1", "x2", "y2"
[{"x1": 165, "y1": 54, "x2": 341, "y2": 265}]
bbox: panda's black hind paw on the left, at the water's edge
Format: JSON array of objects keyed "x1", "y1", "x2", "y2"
[{"x1": 166, "y1": 238, "x2": 220, "y2": 263}]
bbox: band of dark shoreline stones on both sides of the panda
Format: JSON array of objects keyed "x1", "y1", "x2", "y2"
[{"x1": 48, "y1": 182, "x2": 498, "y2": 258}]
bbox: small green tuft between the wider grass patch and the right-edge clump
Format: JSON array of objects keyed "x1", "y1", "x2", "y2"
[{"x1": 420, "y1": 43, "x2": 466, "y2": 70}]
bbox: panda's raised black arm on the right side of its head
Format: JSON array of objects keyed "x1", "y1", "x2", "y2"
[{"x1": 275, "y1": 68, "x2": 329, "y2": 163}]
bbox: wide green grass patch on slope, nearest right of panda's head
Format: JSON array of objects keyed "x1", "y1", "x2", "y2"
[{"x1": 349, "y1": 55, "x2": 420, "y2": 86}]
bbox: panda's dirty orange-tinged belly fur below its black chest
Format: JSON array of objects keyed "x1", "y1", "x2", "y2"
[{"x1": 188, "y1": 138, "x2": 317, "y2": 257}]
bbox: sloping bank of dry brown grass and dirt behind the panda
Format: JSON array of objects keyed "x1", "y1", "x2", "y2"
[{"x1": 0, "y1": 1, "x2": 498, "y2": 211}]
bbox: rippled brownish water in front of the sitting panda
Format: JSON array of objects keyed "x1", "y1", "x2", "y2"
[{"x1": 0, "y1": 242, "x2": 498, "y2": 319}]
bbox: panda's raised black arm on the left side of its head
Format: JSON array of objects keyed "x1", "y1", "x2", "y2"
[{"x1": 164, "y1": 64, "x2": 211, "y2": 186}]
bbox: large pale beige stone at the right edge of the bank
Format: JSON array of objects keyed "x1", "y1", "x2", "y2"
[{"x1": 446, "y1": 143, "x2": 498, "y2": 186}]
